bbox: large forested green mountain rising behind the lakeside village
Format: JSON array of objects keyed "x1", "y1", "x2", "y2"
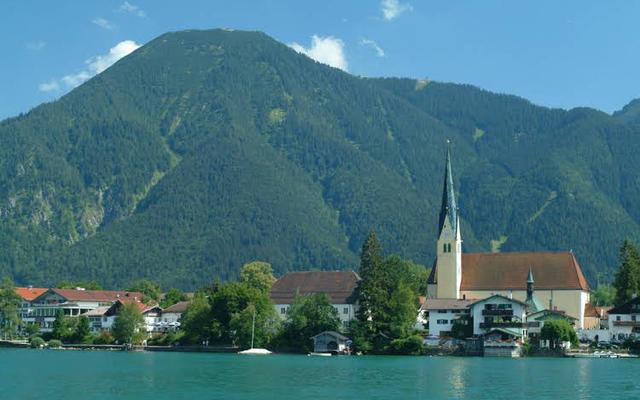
[{"x1": 0, "y1": 30, "x2": 640, "y2": 289}]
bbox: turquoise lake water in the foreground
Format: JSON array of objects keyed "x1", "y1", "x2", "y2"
[{"x1": 0, "y1": 349, "x2": 640, "y2": 400}]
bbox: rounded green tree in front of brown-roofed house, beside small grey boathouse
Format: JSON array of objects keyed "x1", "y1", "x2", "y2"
[{"x1": 280, "y1": 294, "x2": 341, "y2": 352}]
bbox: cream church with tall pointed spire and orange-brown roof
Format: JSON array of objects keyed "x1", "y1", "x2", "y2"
[{"x1": 427, "y1": 150, "x2": 590, "y2": 328}]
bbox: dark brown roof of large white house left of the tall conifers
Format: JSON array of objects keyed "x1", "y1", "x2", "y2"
[{"x1": 271, "y1": 271, "x2": 360, "y2": 304}]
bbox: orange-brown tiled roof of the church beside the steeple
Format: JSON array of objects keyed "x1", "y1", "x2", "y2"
[{"x1": 428, "y1": 252, "x2": 590, "y2": 291}]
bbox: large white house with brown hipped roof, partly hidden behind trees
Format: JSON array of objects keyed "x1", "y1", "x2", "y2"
[{"x1": 271, "y1": 271, "x2": 360, "y2": 328}]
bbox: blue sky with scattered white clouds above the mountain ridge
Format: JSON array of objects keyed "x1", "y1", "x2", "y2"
[{"x1": 0, "y1": 0, "x2": 640, "y2": 119}]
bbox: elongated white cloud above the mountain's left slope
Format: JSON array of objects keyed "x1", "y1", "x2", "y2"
[{"x1": 38, "y1": 40, "x2": 140, "y2": 92}]
